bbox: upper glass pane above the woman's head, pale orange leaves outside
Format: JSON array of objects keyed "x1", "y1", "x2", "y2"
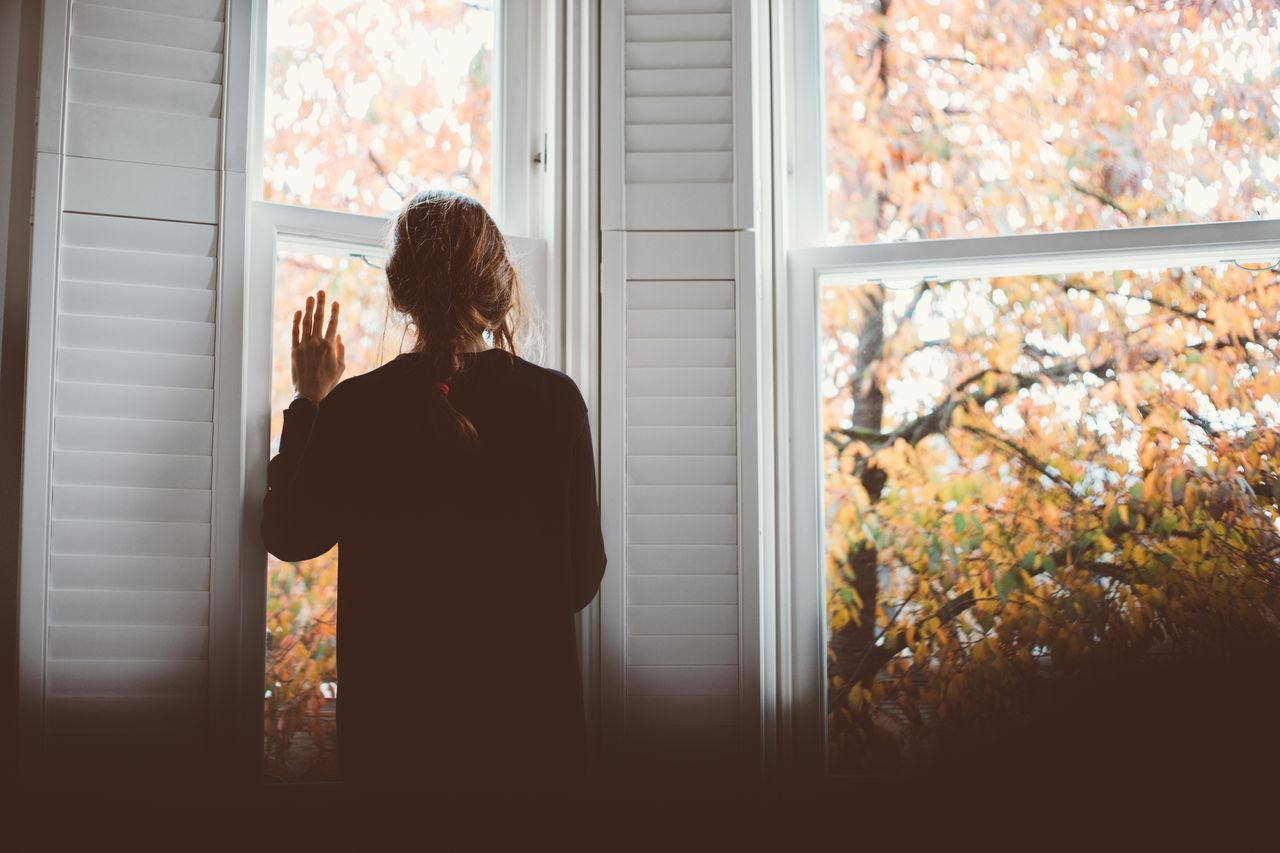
[{"x1": 262, "y1": 0, "x2": 494, "y2": 215}]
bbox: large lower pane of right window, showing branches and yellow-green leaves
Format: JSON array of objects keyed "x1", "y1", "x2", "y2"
[{"x1": 819, "y1": 258, "x2": 1280, "y2": 772}]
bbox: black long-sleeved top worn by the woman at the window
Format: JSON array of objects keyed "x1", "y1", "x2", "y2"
[{"x1": 261, "y1": 350, "x2": 604, "y2": 785}]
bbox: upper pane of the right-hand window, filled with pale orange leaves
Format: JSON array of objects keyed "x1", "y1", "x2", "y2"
[{"x1": 822, "y1": 0, "x2": 1280, "y2": 243}]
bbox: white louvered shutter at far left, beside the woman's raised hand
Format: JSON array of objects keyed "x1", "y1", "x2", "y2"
[{"x1": 19, "y1": 0, "x2": 248, "y2": 772}]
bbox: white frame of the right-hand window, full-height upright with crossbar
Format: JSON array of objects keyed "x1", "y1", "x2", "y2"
[{"x1": 765, "y1": 0, "x2": 1280, "y2": 783}]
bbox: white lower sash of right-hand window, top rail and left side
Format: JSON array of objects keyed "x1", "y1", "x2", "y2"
[{"x1": 777, "y1": 219, "x2": 1280, "y2": 780}]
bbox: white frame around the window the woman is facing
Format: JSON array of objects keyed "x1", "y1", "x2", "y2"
[{"x1": 231, "y1": 0, "x2": 570, "y2": 779}]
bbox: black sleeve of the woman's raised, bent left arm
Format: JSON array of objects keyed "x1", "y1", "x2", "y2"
[{"x1": 261, "y1": 393, "x2": 340, "y2": 562}]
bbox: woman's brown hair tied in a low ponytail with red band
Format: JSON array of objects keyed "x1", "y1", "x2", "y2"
[{"x1": 387, "y1": 190, "x2": 524, "y2": 443}]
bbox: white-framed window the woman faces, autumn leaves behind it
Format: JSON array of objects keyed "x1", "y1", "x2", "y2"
[{"x1": 246, "y1": 0, "x2": 553, "y2": 781}]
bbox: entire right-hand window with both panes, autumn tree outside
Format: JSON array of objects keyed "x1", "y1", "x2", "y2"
[{"x1": 780, "y1": 0, "x2": 1280, "y2": 774}]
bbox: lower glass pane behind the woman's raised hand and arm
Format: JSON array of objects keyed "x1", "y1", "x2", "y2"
[{"x1": 265, "y1": 245, "x2": 404, "y2": 780}]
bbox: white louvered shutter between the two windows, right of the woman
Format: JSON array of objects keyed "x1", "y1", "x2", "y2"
[{"x1": 600, "y1": 0, "x2": 758, "y2": 777}]
